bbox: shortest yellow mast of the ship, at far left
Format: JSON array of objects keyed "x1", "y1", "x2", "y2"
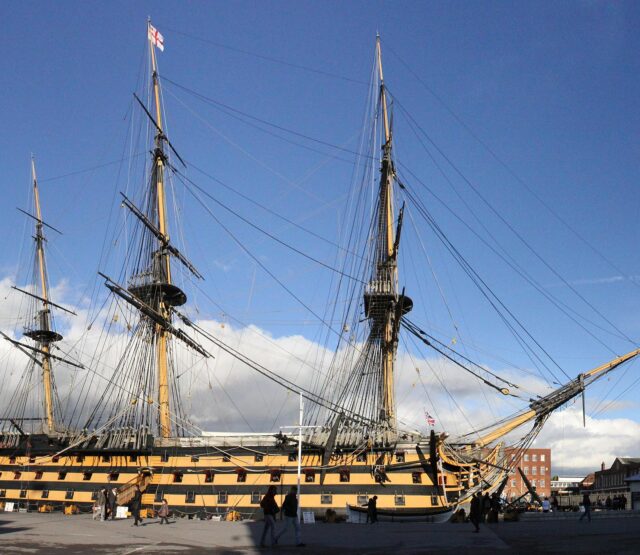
[{"x1": 24, "y1": 157, "x2": 62, "y2": 433}]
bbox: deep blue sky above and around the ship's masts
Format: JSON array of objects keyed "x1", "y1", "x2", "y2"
[{"x1": 0, "y1": 2, "x2": 640, "y2": 474}]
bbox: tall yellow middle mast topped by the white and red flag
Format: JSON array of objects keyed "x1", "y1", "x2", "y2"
[{"x1": 147, "y1": 22, "x2": 172, "y2": 438}]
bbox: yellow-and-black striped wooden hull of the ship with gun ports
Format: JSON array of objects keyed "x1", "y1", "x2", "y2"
[{"x1": 0, "y1": 434, "x2": 497, "y2": 519}]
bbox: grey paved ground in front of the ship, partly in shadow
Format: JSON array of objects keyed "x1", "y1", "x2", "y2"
[{"x1": 0, "y1": 513, "x2": 640, "y2": 555}]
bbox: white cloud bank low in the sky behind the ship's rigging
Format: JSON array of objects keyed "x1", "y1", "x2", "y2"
[{"x1": 0, "y1": 279, "x2": 640, "y2": 474}]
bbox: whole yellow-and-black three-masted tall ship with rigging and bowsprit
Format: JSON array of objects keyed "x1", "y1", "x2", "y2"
[{"x1": 0, "y1": 23, "x2": 640, "y2": 520}]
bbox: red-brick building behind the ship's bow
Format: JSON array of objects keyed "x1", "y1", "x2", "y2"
[{"x1": 504, "y1": 447, "x2": 551, "y2": 500}]
